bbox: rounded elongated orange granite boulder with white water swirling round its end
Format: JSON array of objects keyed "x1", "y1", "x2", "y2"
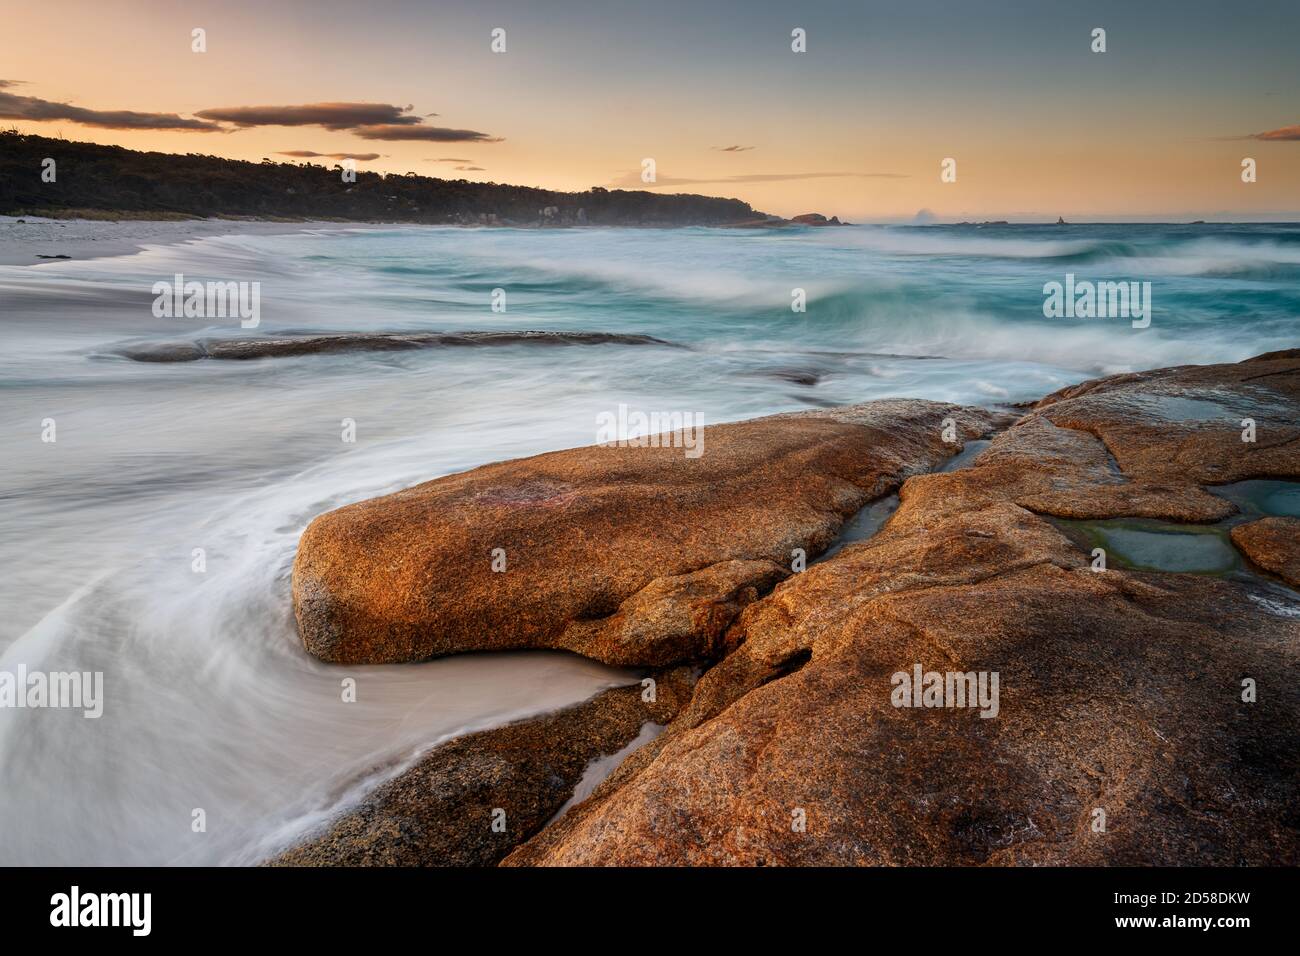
[{"x1": 293, "y1": 401, "x2": 995, "y2": 666}]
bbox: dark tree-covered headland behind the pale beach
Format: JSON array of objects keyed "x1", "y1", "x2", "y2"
[{"x1": 0, "y1": 130, "x2": 780, "y2": 226}]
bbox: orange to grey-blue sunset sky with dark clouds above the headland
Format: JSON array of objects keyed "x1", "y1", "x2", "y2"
[{"x1": 0, "y1": 0, "x2": 1300, "y2": 221}]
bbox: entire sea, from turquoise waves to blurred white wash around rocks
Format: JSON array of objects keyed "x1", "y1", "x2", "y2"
[{"x1": 0, "y1": 224, "x2": 1300, "y2": 864}]
